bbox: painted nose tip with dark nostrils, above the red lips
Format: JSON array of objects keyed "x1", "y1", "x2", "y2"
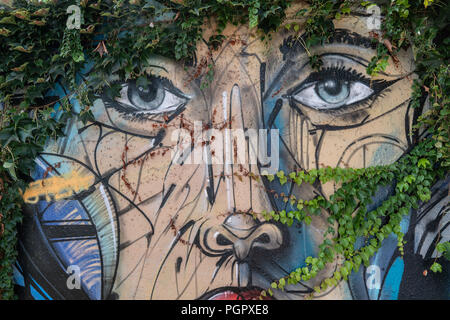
[{"x1": 203, "y1": 213, "x2": 283, "y2": 262}]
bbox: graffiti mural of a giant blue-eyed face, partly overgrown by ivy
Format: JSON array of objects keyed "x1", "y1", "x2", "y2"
[{"x1": 15, "y1": 2, "x2": 450, "y2": 300}]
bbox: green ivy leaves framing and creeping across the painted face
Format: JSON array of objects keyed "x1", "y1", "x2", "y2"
[{"x1": 0, "y1": 0, "x2": 450, "y2": 299}]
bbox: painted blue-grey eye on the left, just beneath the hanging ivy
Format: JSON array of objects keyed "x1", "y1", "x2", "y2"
[{"x1": 115, "y1": 77, "x2": 189, "y2": 114}]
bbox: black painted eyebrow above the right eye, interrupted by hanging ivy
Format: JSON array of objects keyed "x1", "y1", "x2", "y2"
[{"x1": 279, "y1": 29, "x2": 377, "y2": 60}]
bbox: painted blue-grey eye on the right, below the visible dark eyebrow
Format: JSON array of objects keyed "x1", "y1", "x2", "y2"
[{"x1": 292, "y1": 78, "x2": 374, "y2": 110}]
